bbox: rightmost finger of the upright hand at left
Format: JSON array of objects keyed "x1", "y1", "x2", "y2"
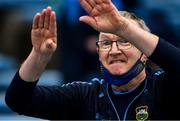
[{"x1": 49, "y1": 11, "x2": 57, "y2": 40}]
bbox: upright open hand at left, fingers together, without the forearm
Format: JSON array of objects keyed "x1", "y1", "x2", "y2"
[{"x1": 31, "y1": 7, "x2": 57, "y2": 56}]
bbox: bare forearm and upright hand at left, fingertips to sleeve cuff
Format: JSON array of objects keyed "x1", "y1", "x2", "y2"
[{"x1": 19, "y1": 7, "x2": 57, "y2": 82}]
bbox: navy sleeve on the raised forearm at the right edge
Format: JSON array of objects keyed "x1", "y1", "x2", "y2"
[{"x1": 149, "y1": 39, "x2": 180, "y2": 79}]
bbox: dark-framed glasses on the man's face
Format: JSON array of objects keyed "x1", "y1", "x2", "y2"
[{"x1": 96, "y1": 40, "x2": 132, "y2": 51}]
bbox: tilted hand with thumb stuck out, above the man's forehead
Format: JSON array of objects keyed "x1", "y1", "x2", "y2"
[{"x1": 80, "y1": 0, "x2": 127, "y2": 33}]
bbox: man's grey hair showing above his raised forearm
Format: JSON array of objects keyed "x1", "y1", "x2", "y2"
[{"x1": 119, "y1": 11, "x2": 150, "y2": 32}]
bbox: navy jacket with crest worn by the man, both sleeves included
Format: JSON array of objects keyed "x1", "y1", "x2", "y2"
[{"x1": 5, "y1": 39, "x2": 180, "y2": 120}]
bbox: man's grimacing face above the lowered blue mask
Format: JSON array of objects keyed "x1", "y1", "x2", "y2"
[{"x1": 98, "y1": 33, "x2": 141, "y2": 75}]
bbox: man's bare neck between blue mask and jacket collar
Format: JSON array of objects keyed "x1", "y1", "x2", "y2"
[{"x1": 112, "y1": 69, "x2": 146, "y2": 92}]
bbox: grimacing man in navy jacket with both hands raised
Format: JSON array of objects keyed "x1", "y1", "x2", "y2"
[{"x1": 6, "y1": 0, "x2": 180, "y2": 120}]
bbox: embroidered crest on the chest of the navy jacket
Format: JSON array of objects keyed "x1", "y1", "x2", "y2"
[{"x1": 136, "y1": 106, "x2": 148, "y2": 121}]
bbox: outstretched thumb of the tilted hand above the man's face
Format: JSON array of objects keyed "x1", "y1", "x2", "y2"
[{"x1": 79, "y1": 16, "x2": 97, "y2": 30}]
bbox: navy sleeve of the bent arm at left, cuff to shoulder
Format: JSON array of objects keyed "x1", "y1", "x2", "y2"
[{"x1": 5, "y1": 73, "x2": 93, "y2": 120}]
